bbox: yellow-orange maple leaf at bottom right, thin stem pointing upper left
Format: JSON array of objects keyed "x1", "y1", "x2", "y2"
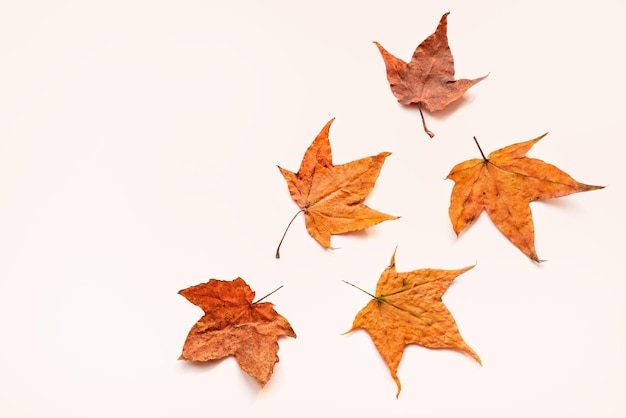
[{"x1": 346, "y1": 251, "x2": 482, "y2": 397}]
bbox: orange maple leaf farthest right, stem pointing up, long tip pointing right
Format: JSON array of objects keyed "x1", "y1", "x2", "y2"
[{"x1": 447, "y1": 134, "x2": 603, "y2": 262}]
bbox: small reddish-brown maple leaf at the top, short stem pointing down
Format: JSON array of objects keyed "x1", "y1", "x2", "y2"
[{"x1": 374, "y1": 13, "x2": 487, "y2": 138}]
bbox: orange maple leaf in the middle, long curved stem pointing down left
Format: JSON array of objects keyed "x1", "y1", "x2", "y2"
[{"x1": 276, "y1": 119, "x2": 398, "y2": 258}]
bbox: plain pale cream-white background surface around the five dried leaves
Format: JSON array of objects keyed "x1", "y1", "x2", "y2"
[{"x1": 0, "y1": 0, "x2": 626, "y2": 417}]
